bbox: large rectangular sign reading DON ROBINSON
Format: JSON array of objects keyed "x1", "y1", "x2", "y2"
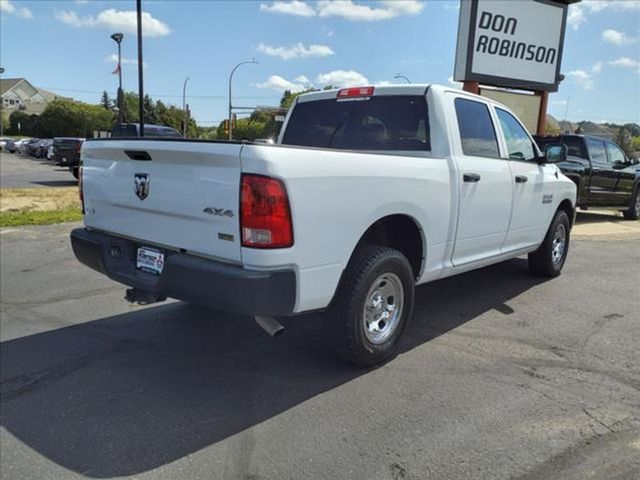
[{"x1": 454, "y1": 0, "x2": 567, "y2": 91}]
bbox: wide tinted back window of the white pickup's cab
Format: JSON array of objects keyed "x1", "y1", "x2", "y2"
[{"x1": 282, "y1": 95, "x2": 430, "y2": 150}]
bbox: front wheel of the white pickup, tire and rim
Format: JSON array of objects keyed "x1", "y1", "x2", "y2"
[{"x1": 529, "y1": 210, "x2": 571, "y2": 277}]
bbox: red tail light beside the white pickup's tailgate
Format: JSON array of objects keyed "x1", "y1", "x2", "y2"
[{"x1": 240, "y1": 174, "x2": 293, "y2": 248}]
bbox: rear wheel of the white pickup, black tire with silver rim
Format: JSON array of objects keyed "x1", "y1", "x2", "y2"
[{"x1": 324, "y1": 246, "x2": 415, "y2": 367}]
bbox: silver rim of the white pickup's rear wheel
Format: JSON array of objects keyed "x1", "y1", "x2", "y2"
[{"x1": 362, "y1": 273, "x2": 404, "y2": 345}]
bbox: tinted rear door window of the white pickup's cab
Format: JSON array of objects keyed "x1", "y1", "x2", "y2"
[{"x1": 455, "y1": 98, "x2": 500, "y2": 158}]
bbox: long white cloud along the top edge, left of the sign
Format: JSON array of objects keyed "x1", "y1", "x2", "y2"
[{"x1": 260, "y1": 0, "x2": 424, "y2": 22}]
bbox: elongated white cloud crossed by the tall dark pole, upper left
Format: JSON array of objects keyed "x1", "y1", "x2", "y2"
[{"x1": 55, "y1": 8, "x2": 171, "y2": 37}]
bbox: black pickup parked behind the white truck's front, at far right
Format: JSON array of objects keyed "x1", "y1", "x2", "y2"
[{"x1": 534, "y1": 134, "x2": 640, "y2": 220}]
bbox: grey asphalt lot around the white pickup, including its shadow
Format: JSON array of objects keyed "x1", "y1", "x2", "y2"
[{"x1": 0, "y1": 214, "x2": 640, "y2": 480}]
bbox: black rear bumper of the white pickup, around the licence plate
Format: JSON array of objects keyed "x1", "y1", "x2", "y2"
[{"x1": 71, "y1": 228, "x2": 296, "y2": 316}]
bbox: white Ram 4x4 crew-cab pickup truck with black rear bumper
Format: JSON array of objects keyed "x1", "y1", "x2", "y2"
[{"x1": 71, "y1": 85, "x2": 576, "y2": 366}]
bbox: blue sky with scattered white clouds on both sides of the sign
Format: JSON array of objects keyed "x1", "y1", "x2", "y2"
[{"x1": 0, "y1": 0, "x2": 640, "y2": 126}]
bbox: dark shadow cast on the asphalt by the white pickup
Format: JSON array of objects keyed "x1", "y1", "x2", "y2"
[{"x1": 0, "y1": 259, "x2": 542, "y2": 478}]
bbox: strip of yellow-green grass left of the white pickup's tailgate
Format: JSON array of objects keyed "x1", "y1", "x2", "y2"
[{"x1": 0, "y1": 187, "x2": 82, "y2": 228}]
